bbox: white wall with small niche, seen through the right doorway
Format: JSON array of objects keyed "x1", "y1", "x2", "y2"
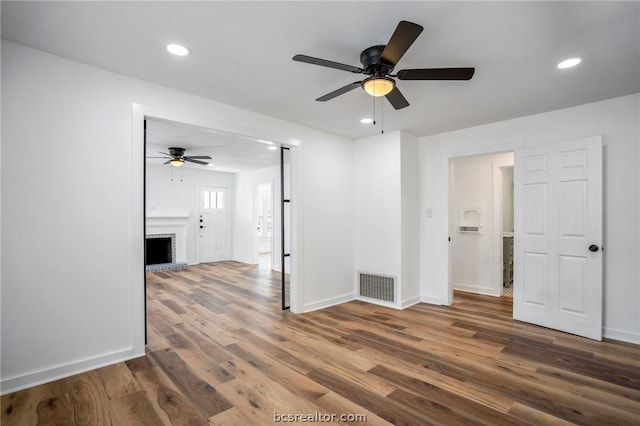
[{"x1": 449, "y1": 153, "x2": 513, "y2": 296}]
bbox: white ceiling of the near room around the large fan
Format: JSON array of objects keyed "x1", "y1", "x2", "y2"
[{"x1": 2, "y1": 1, "x2": 640, "y2": 143}]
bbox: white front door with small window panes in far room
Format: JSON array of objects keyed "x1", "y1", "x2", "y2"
[{"x1": 196, "y1": 186, "x2": 230, "y2": 263}]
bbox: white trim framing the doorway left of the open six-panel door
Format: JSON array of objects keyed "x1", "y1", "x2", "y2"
[{"x1": 438, "y1": 139, "x2": 525, "y2": 306}]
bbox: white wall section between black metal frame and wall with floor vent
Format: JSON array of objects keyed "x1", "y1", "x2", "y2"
[{"x1": 298, "y1": 132, "x2": 355, "y2": 311}]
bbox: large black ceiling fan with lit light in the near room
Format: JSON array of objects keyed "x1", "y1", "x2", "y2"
[{"x1": 293, "y1": 21, "x2": 475, "y2": 109}]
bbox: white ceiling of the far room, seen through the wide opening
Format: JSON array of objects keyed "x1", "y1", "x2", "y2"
[{"x1": 146, "y1": 118, "x2": 280, "y2": 173}]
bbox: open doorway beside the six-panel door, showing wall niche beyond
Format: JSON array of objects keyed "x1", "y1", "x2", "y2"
[{"x1": 449, "y1": 152, "x2": 514, "y2": 300}]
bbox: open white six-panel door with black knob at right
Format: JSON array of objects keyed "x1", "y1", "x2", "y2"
[{"x1": 513, "y1": 136, "x2": 602, "y2": 340}]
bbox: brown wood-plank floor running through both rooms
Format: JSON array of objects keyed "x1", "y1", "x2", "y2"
[{"x1": 2, "y1": 262, "x2": 640, "y2": 425}]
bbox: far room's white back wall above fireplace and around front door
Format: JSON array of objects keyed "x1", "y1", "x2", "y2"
[{"x1": 146, "y1": 165, "x2": 234, "y2": 265}]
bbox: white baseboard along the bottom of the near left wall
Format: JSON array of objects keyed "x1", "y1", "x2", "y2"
[{"x1": 0, "y1": 348, "x2": 144, "y2": 395}]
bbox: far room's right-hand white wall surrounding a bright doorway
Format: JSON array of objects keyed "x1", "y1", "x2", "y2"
[{"x1": 232, "y1": 166, "x2": 282, "y2": 270}]
